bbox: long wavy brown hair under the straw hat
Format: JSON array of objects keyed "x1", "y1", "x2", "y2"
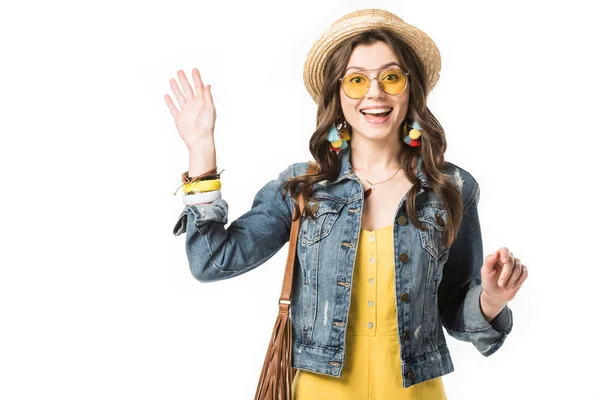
[{"x1": 283, "y1": 29, "x2": 463, "y2": 247}]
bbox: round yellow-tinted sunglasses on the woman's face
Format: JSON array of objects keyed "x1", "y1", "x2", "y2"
[{"x1": 339, "y1": 69, "x2": 408, "y2": 99}]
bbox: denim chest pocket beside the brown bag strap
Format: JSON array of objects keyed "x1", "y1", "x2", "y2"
[{"x1": 300, "y1": 198, "x2": 345, "y2": 246}]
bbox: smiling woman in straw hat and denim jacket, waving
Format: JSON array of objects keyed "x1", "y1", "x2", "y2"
[{"x1": 166, "y1": 10, "x2": 528, "y2": 400}]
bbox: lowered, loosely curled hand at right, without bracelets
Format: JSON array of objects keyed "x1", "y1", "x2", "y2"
[{"x1": 481, "y1": 247, "x2": 529, "y2": 304}]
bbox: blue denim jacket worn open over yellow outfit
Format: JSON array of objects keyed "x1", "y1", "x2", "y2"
[{"x1": 173, "y1": 147, "x2": 513, "y2": 388}]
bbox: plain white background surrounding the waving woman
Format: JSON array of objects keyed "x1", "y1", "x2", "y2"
[{"x1": 0, "y1": 0, "x2": 600, "y2": 399}]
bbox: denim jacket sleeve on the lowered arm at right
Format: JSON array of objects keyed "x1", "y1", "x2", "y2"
[{"x1": 438, "y1": 180, "x2": 513, "y2": 357}]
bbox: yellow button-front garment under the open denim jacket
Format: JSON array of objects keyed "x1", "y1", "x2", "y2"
[{"x1": 292, "y1": 225, "x2": 447, "y2": 400}]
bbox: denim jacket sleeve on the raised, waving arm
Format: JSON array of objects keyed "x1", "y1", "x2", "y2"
[{"x1": 173, "y1": 165, "x2": 292, "y2": 282}]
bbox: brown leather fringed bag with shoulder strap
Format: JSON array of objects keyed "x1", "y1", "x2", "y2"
[{"x1": 254, "y1": 161, "x2": 317, "y2": 400}]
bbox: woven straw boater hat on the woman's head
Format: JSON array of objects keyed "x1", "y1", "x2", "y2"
[{"x1": 304, "y1": 9, "x2": 442, "y2": 103}]
